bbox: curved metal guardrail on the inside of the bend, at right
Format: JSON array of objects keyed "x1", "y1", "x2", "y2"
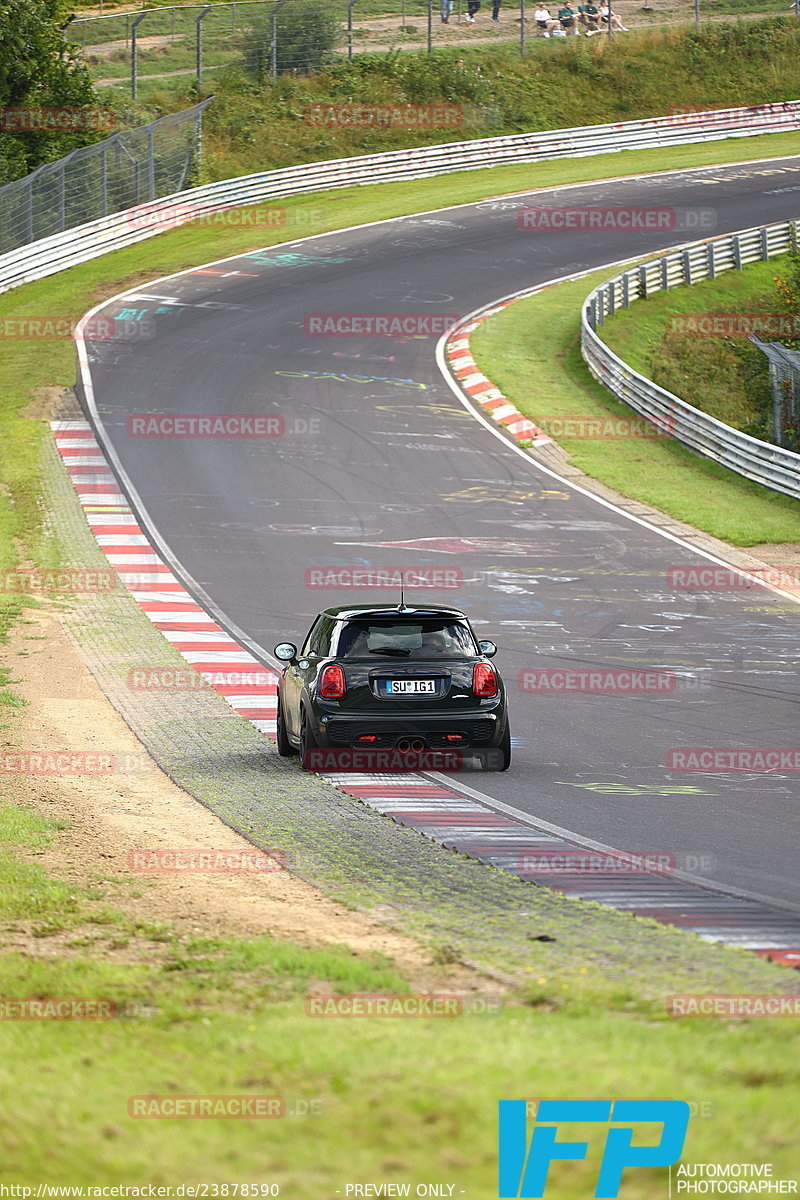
[{"x1": 581, "y1": 221, "x2": 800, "y2": 499}]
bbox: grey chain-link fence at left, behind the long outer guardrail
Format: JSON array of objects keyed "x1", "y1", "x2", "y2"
[{"x1": 0, "y1": 98, "x2": 211, "y2": 254}]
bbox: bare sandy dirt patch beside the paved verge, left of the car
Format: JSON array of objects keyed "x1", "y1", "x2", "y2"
[{"x1": 0, "y1": 606, "x2": 494, "y2": 991}]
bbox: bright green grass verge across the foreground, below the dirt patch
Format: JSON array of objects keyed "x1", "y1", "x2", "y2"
[{"x1": 0, "y1": 806, "x2": 800, "y2": 1200}]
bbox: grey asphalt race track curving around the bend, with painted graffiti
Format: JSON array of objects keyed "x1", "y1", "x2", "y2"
[{"x1": 77, "y1": 151, "x2": 800, "y2": 907}]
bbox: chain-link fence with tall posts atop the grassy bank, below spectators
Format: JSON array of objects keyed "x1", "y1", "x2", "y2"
[{"x1": 67, "y1": 0, "x2": 800, "y2": 97}]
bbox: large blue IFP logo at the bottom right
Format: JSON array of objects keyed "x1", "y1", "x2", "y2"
[{"x1": 498, "y1": 1100, "x2": 690, "y2": 1200}]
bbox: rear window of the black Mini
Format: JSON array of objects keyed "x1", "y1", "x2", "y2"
[{"x1": 335, "y1": 617, "x2": 479, "y2": 660}]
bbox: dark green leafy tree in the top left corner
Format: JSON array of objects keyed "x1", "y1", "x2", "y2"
[{"x1": 0, "y1": 0, "x2": 98, "y2": 184}]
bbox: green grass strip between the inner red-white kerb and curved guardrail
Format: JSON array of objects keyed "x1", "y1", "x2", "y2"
[{"x1": 471, "y1": 262, "x2": 800, "y2": 546}]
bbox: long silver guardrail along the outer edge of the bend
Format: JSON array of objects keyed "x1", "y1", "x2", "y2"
[{"x1": 0, "y1": 100, "x2": 800, "y2": 292}]
